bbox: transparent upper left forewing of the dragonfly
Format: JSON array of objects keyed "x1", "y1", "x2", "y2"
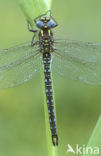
[{"x1": 0, "y1": 43, "x2": 38, "y2": 69}]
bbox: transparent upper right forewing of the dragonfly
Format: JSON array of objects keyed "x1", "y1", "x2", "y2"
[{"x1": 54, "y1": 40, "x2": 101, "y2": 62}]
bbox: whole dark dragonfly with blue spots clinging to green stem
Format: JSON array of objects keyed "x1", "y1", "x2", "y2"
[{"x1": 0, "y1": 10, "x2": 101, "y2": 146}]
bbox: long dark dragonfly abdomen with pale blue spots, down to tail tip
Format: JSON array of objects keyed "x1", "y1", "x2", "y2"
[{"x1": 43, "y1": 53, "x2": 58, "y2": 145}]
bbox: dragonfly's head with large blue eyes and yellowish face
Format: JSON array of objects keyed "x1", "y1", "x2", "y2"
[{"x1": 36, "y1": 17, "x2": 55, "y2": 30}]
